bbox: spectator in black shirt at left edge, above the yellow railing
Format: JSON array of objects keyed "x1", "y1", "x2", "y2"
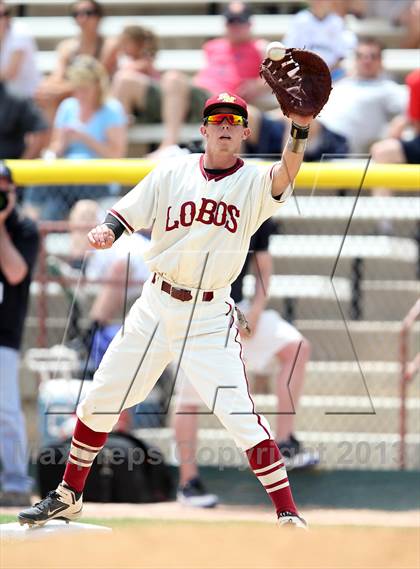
[{"x1": 0, "y1": 80, "x2": 48, "y2": 159}]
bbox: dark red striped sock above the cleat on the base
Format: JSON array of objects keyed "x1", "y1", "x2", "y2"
[{"x1": 63, "y1": 419, "x2": 108, "y2": 492}]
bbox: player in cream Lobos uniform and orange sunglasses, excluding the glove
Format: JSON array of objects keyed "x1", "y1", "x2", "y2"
[{"x1": 19, "y1": 92, "x2": 313, "y2": 528}]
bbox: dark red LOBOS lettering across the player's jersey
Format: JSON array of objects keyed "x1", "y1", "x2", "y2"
[{"x1": 166, "y1": 198, "x2": 241, "y2": 233}]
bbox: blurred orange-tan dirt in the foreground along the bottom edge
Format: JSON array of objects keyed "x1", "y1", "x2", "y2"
[{"x1": 0, "y1": 520, "x2": 420, "y2": 569}]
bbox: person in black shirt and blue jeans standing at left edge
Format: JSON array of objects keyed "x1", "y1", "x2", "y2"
[{"x1": 0, "y1": 164, "x2": 39, "y2": 507}]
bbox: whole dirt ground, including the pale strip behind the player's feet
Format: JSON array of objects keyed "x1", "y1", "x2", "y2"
[{"x1": 0, "y1": 503, "x2": 420, "y2": 569}]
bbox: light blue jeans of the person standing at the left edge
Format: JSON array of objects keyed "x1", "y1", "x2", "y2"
[{"x1": 0, "y1": 346, "x2": 32, "y2": 492}]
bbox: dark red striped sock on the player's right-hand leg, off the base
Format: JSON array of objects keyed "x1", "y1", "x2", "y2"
[{"x1": 246, "y1": 439, "x2": 298, "y2": 515}]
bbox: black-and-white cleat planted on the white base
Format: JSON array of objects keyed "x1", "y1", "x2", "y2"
[{"x1": 18, "y1": 483, "x2": 83, "y2": 526}]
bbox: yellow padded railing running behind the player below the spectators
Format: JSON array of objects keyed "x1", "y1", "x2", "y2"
[{"x1": 6, "y1": 158, "x2": 420, "y2": 191}]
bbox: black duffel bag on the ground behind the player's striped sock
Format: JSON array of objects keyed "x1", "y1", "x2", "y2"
[{"x1": 37, "y1": 433, "x2": 174, "y2": 503}]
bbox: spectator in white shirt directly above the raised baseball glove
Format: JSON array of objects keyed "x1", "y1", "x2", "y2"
[{"x1": 283, "y1": 0, "x2": 356, "y2": 79}]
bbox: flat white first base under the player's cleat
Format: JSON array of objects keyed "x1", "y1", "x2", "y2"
[{"x1": 0, "y1": 520, "x2": 112, "y2": 543}]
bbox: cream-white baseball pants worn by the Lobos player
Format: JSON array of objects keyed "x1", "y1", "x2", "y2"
[{"x1": 77, "y1": 275, "x2": 272, "y2": 450}]
